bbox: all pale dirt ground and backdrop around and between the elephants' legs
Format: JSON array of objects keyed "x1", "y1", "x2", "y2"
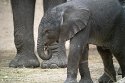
[{"x1": 0, "y1": 0, "x2": 121, "y2": 83}]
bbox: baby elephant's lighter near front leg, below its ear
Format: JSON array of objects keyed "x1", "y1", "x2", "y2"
[{"x1": 64, "y1": 27, "x2": 89, "y2": 83}]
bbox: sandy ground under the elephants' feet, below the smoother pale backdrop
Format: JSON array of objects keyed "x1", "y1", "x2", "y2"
[{"x1": 0, "y1": 49, "x2": 121, "y2": 83}]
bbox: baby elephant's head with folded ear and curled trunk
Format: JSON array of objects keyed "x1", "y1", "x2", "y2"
[{"x1": 37, "y1": 5, "x2": 89, "y2": 59}]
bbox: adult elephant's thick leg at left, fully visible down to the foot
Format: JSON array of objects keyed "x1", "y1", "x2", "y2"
[{"x1": 9, "y1": 0, "x2": 40, "y2": 68}]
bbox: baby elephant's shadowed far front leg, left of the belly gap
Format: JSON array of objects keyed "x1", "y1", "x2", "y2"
[{"x1": 79, "y1": 45, "x2": 93, "y2": 83}]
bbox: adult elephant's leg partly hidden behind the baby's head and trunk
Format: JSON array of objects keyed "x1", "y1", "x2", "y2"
[{"x1": 41, "y1": 0, "x2": 67, "y2": 68}]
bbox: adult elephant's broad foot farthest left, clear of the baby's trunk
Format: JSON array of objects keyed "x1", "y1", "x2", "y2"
[{"x1": 9, "y1": 53, "x2": 40, "y2": 68}]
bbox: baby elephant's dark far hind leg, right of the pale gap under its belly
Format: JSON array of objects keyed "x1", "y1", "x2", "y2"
[{"x1": 97, "y1": 46, "x2": 116, "y2": 83}]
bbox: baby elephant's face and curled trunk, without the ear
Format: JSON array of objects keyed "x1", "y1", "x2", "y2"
[{"x1": 37, "y1": 9, "x2": 59, "y2": 60}]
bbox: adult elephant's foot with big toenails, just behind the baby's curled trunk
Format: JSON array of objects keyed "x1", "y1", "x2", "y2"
[{"x1": 41, "y1": 53, "x2": 67, "y2": 69}]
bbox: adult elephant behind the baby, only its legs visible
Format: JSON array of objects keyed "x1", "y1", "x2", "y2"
[{"x1": 9, "y1": 0, "x2": 67, "y2": 68}]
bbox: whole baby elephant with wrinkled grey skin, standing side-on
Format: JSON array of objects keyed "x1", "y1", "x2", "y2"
[{"x1": 38, "y1": 0, "x2": 125, "y2": 83}]
